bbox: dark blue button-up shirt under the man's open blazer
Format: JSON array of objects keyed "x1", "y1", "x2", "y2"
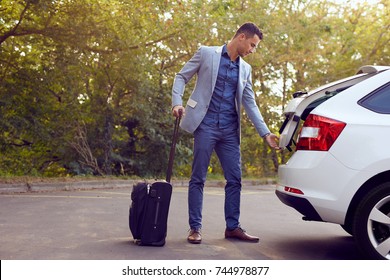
[{"x1": 203, "y1": 45, "x2": 240, "y2": 129}]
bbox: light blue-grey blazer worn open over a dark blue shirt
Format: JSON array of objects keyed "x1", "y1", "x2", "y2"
[{"x1": 172, "y1": 46, "x2": 270, "y2": 139}]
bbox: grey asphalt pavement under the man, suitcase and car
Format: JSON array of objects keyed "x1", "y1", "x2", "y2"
[{"x1": 0, "y1": 185, "x2": 362, "y2": 260}]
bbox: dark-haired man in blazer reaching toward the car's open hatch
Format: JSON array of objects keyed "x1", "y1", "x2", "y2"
[{"x1": 172, "y1": 23, "x2": 278, "y2": 244}]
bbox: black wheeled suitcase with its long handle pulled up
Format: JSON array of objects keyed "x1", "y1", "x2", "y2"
[{"x1": 129, "y1": 110, "x2": 181, "y2": 246}]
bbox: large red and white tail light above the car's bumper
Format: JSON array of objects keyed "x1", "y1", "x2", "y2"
[{"x1": 297, "y1": 115, "x2": 346, "y2": 151}]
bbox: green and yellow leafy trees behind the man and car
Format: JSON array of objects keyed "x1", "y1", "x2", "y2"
[{"x1": 0, "y1": 0, "x2": 390, "y2": 177}]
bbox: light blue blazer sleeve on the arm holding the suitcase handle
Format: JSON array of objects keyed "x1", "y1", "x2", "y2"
[{"x1": 172, "y1": 47, "x2": 202, "y2": 108}]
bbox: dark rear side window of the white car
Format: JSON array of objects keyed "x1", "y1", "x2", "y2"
[{"x1": 358, "y1": 83, "x2": 390, "y2": 114}]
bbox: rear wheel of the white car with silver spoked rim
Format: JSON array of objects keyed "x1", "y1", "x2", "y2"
[{"x1": 352, "y1": 182, "x2": 390, "y2": 260}]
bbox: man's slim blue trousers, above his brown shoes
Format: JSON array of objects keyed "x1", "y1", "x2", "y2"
[{"x1": 188, "y1": 124, "x2": 241, "y2": 229}]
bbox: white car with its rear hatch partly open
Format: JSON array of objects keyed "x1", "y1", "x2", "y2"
[{"x1": 276, "y1": 66, "x2": 390, "y2": 260}]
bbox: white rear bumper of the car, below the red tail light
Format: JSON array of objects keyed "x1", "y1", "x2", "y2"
[{"x1": 277, "y1": 151, "x2": 358, "y2": 224}]
